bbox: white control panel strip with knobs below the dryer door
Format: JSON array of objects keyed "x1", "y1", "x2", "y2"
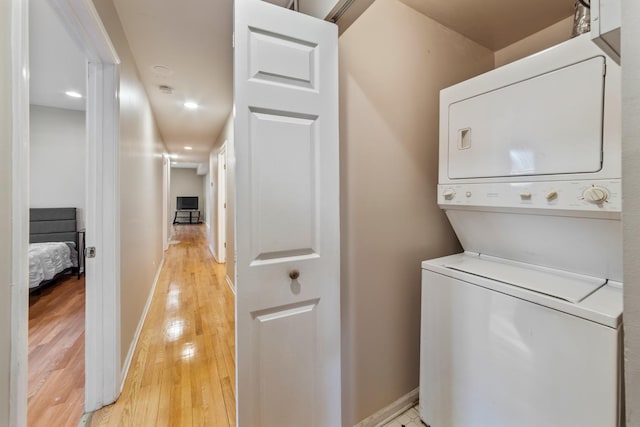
[{"x1": 438, "y1": 179, "x2": 622, "y2": 212}]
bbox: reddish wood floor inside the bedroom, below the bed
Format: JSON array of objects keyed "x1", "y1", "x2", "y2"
[{"x1": 27, "y1": 276, "x2": 85, "y2": 427}]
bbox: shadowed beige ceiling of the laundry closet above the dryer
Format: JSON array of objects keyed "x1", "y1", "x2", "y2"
[{"x1": 400, "y1": 0, "x2": 575, "y2": 51}]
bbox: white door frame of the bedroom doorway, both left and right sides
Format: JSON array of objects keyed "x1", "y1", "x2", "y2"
[{"x1": 10, "y1": 0, "x2": 121, "y2": 426}]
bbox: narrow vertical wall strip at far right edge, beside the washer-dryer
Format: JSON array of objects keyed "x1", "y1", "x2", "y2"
[{"x1": 622, "y1": 0, "x2": 640, "y2": 427}]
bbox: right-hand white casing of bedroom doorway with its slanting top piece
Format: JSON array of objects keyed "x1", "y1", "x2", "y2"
[{"x1": 54, "y1": 0, "x2": 122, "y2": 412}]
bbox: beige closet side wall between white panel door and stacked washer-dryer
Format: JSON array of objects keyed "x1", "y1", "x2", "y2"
[{"x1": 339, "y1": 0, "x2": 494, "y2": 426}]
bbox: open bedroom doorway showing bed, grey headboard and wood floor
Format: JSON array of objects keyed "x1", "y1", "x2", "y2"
[{"x1": 27, "y1": 0, "x2": 88, "y2": 425}]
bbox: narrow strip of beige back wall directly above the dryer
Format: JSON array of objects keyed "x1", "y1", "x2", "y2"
[{"x1": 495, "y1": 16, "x2": 573, "y2": 68}]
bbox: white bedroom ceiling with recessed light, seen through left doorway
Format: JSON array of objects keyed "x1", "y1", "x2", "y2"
[{"x1": 29, "y1": 0, "x2": 86, "y2": 110}]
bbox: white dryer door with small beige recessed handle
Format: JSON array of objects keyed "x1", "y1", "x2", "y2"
[{"x1": 448, "y1": 56, "x2": 606, "y2": 179}]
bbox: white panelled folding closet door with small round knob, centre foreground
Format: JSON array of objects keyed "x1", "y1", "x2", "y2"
[{"x1": 234, "y1": 0, "x2": 341, "y2": 427}]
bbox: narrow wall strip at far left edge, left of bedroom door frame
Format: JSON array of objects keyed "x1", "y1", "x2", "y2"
[{"x1": 0, "y1": 0, "x2": 12, "y2": 426}]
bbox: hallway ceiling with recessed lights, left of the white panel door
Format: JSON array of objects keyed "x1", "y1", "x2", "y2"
[{"x1": 114, "y1": 0, "x2": 233, "y2": 163}]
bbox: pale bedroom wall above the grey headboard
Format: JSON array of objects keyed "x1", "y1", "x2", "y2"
[{"x1": 29, "y1": 105, "x2": 87, "y2": 229}]
